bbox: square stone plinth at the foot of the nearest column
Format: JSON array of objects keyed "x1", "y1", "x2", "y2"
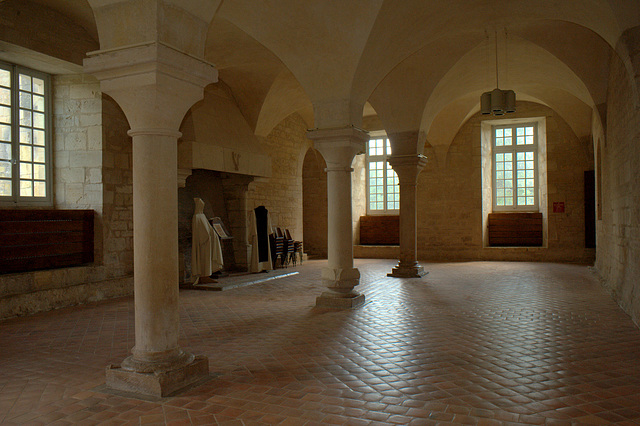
[{"x1": 106, "y1": 356, "x2": 209, "y2": 397}]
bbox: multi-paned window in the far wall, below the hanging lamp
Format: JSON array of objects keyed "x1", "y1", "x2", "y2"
[{"x1": 493, "y1": 124, "x2": 538, "y2": 211}]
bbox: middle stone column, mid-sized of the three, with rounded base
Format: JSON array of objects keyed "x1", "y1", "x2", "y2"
[{"x1": 307, "y1": 127, "x2": 369, "y2": 308}]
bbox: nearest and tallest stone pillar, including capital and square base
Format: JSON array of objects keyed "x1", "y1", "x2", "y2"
[{"x1": 84, "y1": 42, "x2": 217, "y2": 396}]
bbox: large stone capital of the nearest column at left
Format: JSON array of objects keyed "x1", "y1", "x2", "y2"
[{"x1": 84, "y1": 41, "x2": 218, "y2": 130}]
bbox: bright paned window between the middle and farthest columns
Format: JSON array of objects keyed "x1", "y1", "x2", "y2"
[{"x1": 367, "y1": 136, "x2": 400, "y2": 214}]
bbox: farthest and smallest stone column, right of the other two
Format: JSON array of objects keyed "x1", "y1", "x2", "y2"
[{"x1": 387, "y1": 154, "x2": 427, "y2": 278}]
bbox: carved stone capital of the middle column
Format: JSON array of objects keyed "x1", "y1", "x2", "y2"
[{"x1": 307, "y1": 126, "x2": 369, "y2": 167}]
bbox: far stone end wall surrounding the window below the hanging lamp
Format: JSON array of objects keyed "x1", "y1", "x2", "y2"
[{"x1": 417, "y1": 102, "x2": 594, "y2": 263}]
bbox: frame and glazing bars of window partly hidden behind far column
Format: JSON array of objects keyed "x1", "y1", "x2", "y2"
[{"x1": 365, "y1": 131, "x2": 400, "y2": 216}]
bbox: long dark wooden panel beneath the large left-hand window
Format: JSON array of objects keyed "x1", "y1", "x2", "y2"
[{"x1": 0, "y1": 210, "x2": 94, "y2": 274}]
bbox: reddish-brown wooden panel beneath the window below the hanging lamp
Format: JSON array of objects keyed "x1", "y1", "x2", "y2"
[{"x1": 489, "y1": 213, "x2": 542, "y2": 247}]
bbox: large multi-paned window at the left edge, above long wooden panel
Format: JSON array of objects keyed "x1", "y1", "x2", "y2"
[{"x1": 0, "y1": 63, "x2": 51, "y2": 204}]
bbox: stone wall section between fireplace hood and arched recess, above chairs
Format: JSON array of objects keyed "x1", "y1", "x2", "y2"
[{"x1": 247, "y1": 114, "x2": 311, "y2": 245}]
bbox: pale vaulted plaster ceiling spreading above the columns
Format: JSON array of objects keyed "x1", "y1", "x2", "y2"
[{"x1": 26, "y1": 0, "x2": 640, "y2": 151}]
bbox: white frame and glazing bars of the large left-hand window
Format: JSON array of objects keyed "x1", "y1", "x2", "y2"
[{"x1": 0, "y1": 61, "x2": 53, "y2": 207}]
